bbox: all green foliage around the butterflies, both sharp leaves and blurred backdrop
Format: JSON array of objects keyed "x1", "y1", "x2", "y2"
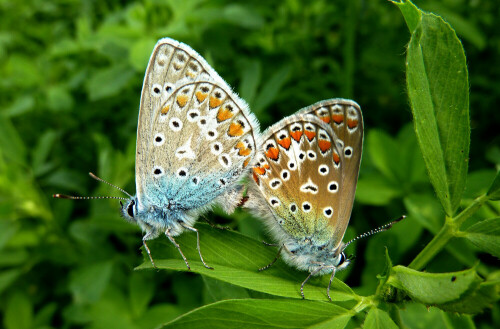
[{"x1": 0, "y1": 0, "x2": 500, "y2": 329}]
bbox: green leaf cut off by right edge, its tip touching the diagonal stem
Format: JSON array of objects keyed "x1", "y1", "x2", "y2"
[{"x1": 460, "y1": 217, "x2": 500, "y2": 258}]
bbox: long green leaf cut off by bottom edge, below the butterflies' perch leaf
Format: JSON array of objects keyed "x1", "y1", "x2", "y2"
[{"x1": 162, "y1": 299, "x2": 352, "y2": 329}]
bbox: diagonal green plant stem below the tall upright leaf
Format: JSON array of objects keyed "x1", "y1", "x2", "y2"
[{"x1": 408, "y1": 195, "x2": 488, "y2": 270}]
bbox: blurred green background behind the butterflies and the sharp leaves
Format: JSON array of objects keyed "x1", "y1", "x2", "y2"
[{"x1": 0, "y1": 0, "x2": 500, "y2": 329}]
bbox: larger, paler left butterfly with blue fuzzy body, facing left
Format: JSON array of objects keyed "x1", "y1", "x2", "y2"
[{"x1": 56, "y1": 38, "x2": 260, "y2": 269}]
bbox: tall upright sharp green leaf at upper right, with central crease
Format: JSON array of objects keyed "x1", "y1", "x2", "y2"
[{"x1": 406, "y1": 14, "x2": 470, "y2": 216}]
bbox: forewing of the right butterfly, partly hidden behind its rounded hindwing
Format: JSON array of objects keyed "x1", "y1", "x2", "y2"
[{"x1": 299, "y1": 98, "x2": 363, "y2": 243}]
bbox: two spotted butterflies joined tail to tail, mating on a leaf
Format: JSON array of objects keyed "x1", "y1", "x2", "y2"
[{"x1": 55, "y1": 38, "x2": 398, "y2": 297}]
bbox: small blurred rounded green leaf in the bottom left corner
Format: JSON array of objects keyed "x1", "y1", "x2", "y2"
[{"x1": 3, "y1": 292, "x2": 33, "y2": 329}]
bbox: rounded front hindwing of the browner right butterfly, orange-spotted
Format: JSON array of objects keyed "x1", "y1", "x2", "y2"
[{"x1": 250, "y1": 114, "x2": 344, "y2": 246}]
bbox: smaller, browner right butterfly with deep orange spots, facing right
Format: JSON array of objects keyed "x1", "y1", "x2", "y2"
[{"x1": 245, "y1": 99, "x2": 402, "y2": 300}]
